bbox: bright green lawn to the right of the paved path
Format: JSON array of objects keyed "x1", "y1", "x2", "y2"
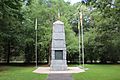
[{"x1": 72, "y1": 64, "x2": 120, "y2": 80}]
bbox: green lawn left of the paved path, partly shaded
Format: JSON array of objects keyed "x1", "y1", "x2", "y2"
[{"x1": 0, "y1": 66, "x2": 47, "y2": 80}]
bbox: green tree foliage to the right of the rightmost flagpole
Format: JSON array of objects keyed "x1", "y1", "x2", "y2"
[{"x1": 75, "y1": 0, "x2": 120, "y2": 63}]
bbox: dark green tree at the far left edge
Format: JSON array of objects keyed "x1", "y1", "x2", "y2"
[{"x1": 0, "y1": 0, "x2": 22, "y2": 63}]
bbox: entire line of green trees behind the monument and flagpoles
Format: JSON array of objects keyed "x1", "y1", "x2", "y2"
[{"x1": 0, "y1": 0, "x2": 120, "y2": 63}]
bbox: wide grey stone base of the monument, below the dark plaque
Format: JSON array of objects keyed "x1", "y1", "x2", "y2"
[{"x1": 50, "y1": 60, "x2": 67, "y2": 71}]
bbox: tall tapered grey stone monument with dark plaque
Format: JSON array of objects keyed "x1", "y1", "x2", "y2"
[{"x1": 50, "y1": 20, "x2": 67, "y2": 71}]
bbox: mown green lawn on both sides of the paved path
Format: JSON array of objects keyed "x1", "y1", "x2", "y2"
[{"x1": 0, "y1": 64, "x2": 120, "y2": 80}]
